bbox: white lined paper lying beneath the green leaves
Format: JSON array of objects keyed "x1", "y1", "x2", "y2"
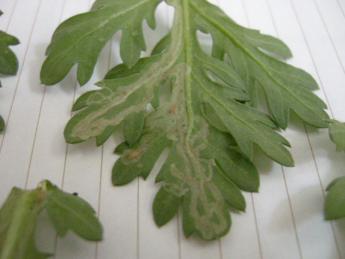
[{"x1": 0, "y1": 0, "x2": 345, "y2": 259}]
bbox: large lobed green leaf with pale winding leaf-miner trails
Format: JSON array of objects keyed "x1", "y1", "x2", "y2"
[{"x1": 41, "y1": 0, "x2": 329, "y2": 240}]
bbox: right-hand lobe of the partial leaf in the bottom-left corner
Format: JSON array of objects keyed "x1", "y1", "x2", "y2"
[{"x1": 45, "y1": 183, "x2": 103, "y2": 241}]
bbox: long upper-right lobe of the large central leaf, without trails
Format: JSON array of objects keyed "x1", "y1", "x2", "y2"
[{"x1": 198, "y1": 0, "x2": 329, "y2": 128}]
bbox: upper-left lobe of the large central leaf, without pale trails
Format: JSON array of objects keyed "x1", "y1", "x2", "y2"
[{"x1": 41, "y1": 0, "x2": 161, "y2": 85}]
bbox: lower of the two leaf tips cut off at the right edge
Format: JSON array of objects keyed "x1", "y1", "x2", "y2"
[{"x1": 325, "y1": 177, "x2": 345, "y2": 220}]
